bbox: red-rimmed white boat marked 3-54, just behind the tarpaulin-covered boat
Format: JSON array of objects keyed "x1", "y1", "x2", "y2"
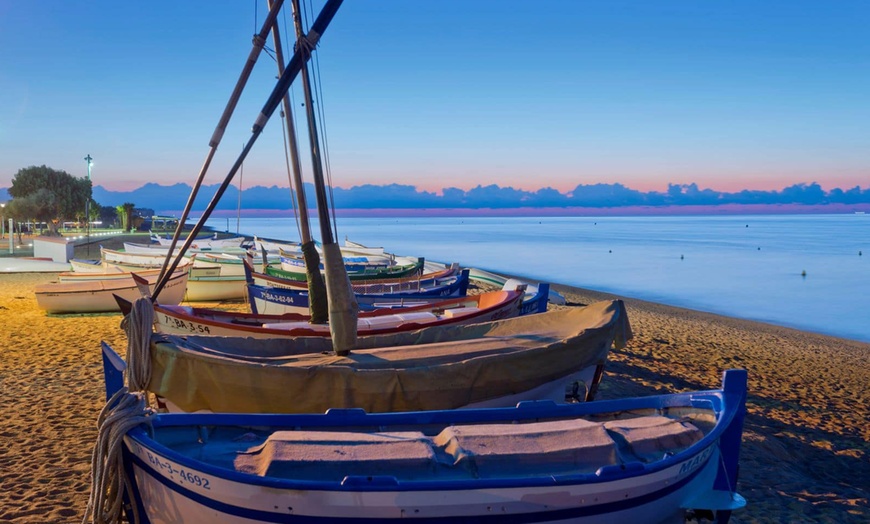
[{"x1": 148, "y1": 290, "x2": 547, "y2": 338}]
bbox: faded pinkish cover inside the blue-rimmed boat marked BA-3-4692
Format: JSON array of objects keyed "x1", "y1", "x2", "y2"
[{"x1": 225, "y1": 415, "x2": 704, "y2": 482}]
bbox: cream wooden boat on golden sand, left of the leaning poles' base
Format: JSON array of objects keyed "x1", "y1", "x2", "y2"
[{"x1": 34, "y1": 266, "x2": 188, "y2": 313}]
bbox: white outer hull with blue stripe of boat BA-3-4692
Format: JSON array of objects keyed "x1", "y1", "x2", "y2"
[{"x1": 124, "y1": 437, "x2": 719, "y2": 524}]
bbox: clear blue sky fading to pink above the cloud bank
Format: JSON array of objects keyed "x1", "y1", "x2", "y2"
[{"x1": 0, "y1": 0, "x2": 870, "y2": 196}]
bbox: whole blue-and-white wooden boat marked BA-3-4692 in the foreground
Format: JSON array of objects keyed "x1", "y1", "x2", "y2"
[{"x1": 97, "y1": 357, "x2": 746, "y2": 524}]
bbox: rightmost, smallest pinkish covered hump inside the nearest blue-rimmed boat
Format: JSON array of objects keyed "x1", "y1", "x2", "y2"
[{"x1": 604, "y1": 416, "x2": 704, "y2": 462}]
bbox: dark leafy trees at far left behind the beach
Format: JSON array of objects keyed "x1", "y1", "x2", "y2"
[{"x1": 3, "y1": 165, "x2": 145, "y2": 236}]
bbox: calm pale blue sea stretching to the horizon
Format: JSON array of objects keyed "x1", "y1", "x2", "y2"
[{"x1": 199, "y1": 214, "x2": 870, "y2": 342}]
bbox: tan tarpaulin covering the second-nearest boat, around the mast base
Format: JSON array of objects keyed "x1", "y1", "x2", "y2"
[{"x1": 149, "y1": 300, "x2": 631, "y2": 413}]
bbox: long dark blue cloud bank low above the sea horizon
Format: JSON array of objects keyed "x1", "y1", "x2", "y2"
[{"x1": 6, "y1": 182, "x2": 870, "y2": 213}]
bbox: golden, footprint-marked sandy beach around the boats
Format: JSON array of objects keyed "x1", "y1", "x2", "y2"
[{"x1": 0, "y1": 237, "x2": 870, "y2": 524}]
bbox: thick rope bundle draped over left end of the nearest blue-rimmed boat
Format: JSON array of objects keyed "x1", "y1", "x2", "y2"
[{"x1": 82, "y1": 388, "x2": 152, "y2": 524}]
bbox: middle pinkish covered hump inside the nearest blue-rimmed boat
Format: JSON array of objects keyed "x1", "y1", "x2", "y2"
[{"x1": 434, "y1": 419, "x2": 618, "y2": 478}]
